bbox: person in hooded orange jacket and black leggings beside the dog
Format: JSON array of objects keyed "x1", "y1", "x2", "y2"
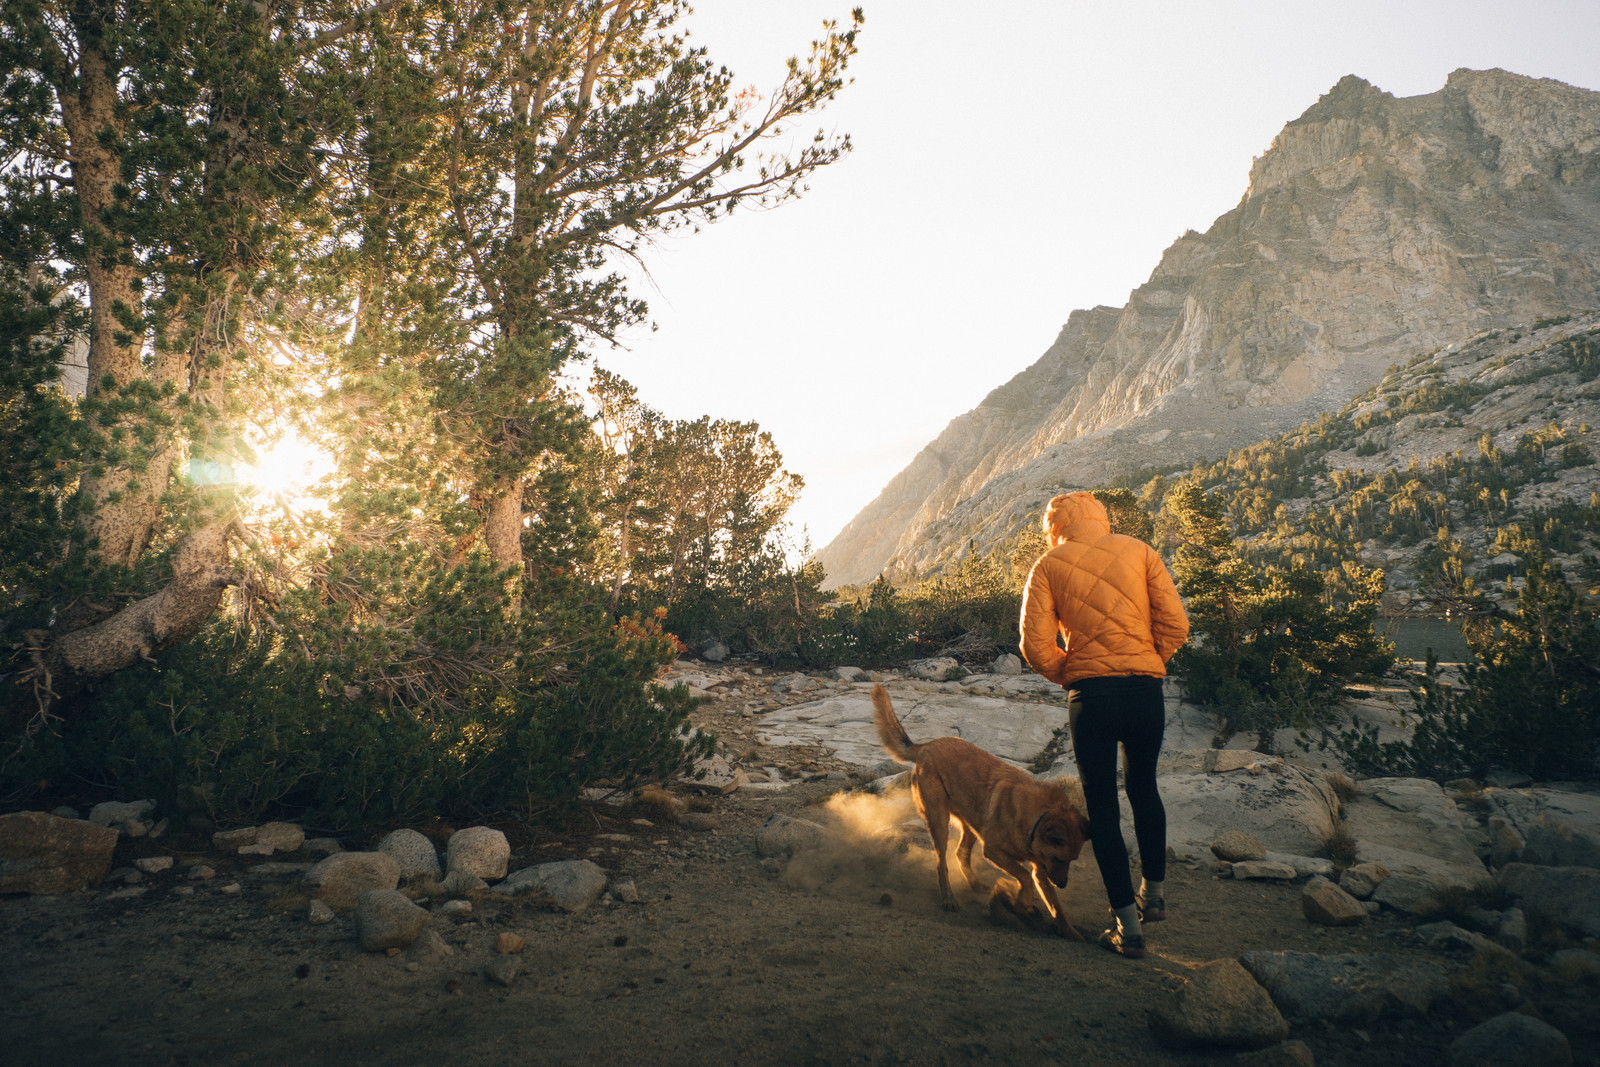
[{"x1": 1021, "y1": 493, "x2": 1189, "y2": 958}]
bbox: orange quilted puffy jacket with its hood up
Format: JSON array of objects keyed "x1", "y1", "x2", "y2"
[{"x1": 1022, "y1": 493, "x2": 1189, "y2": 686}]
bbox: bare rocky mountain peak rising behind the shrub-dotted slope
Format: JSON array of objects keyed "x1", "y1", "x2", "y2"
[{"x1": 819, "y1": 70, "x2": 1600, "y2": 584}]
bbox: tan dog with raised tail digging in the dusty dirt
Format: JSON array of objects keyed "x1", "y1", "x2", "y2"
[{"x1": 872, "y1": 685, "x2": 1090, "y2": 941}]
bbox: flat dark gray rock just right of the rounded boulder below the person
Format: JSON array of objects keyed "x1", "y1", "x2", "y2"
[{"x1": 1240, "y1": 950, "x2": 1450, "y2": 1025}]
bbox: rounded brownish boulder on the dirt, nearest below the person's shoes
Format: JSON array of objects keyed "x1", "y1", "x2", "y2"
[{"x1": 1150, "y1": 960, "x2": 1290, "y2": 1048}]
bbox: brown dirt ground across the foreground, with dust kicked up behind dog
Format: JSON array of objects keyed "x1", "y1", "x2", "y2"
[{"x1": 9, "y1": 687, "x2": 1600, "y2": 1067}]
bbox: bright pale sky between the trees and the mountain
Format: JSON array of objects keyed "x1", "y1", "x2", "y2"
[{"x1": 600, "y1": 0, "x2": 1600, "y2": 559}]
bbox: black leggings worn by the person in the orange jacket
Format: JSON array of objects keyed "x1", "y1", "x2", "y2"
[{"x1": 1067, "y1": 675, "x2": 1166, "y2": 909}]
